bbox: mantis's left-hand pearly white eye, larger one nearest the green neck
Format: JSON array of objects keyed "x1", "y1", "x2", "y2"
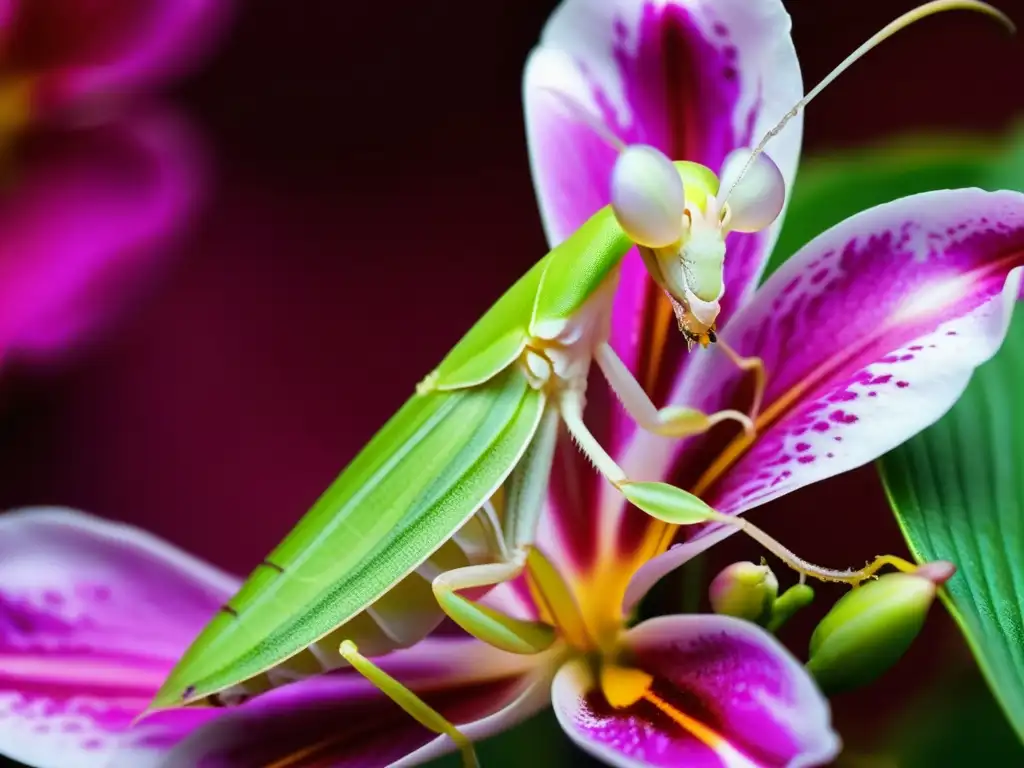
[{"x1": 611, "y1": 144, "x2": 686, "y2": 248}]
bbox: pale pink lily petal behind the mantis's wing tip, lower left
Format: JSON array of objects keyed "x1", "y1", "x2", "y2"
[{"x1": 0, "y1": 509, "x2": 238, "y2": 768}]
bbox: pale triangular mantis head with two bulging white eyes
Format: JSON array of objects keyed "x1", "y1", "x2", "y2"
[{"x1": 611, "y1": 144, "x2": 785, "y2": 346}]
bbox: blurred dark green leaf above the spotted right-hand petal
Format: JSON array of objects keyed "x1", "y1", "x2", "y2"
[{"x1": 763, "y1": 126, "x2": 1024, "y2": 280}]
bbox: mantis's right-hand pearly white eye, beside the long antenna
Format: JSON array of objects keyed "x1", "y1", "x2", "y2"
[{"x1": 720, "y1": 147, "x2": 785, "y2": 232}]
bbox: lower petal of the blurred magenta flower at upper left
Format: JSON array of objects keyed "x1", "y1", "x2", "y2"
[{"x1": 0, "y1": 107, "x2": 201, "y2": 364}]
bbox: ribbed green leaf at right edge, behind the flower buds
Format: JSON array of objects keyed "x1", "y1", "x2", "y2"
[{"x1": 881, "y1": 312, "x2": 1024, "y2": 738}]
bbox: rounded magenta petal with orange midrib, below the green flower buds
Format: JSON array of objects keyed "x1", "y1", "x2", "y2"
[{"x1": 552, "y1": 615, "x2": 840, "y2": 768}]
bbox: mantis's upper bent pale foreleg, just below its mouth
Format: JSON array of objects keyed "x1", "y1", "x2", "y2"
[{"x1": 594, "y1": 342, "x2": 763, "y2": 437}]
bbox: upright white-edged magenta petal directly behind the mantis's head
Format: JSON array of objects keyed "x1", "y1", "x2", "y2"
[{"x1": 523, "y1": 0, "x2": 803, "y2": 405}]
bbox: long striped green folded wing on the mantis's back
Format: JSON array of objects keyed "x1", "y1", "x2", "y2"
[{"x1": 152, "y1": 367, "x2": 544, "y2": 709}]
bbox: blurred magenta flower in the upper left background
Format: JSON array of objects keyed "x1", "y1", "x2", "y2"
[{"x1": 0, "y1": 0, "x2": 229, "y2": 360}]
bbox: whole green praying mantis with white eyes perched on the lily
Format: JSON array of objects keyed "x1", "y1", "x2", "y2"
[{"x1": 151, "y1": 0, "x2": 1010, "y2": 757}]
